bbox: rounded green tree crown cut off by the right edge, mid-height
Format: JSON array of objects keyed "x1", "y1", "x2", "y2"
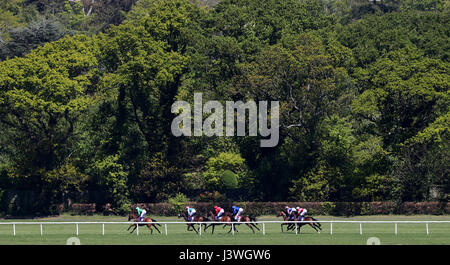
[{"x1": 354, "y1": 47, "x2": 450, "y2": 150}]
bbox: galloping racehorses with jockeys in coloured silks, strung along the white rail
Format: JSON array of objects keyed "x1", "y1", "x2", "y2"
[{"x1": 127, "y1": 208, "x2": 322, "y2": 234}]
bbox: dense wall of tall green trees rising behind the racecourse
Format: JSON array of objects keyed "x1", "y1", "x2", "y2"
[{"x1": 0, "y1": 0, "x2": 450, "y2": 214}]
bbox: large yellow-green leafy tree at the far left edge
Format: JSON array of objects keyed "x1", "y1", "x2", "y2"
[{"x1": 0, "y1": 36, "x2": 98, "y2": 211}]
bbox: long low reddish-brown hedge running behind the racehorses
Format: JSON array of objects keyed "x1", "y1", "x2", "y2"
[{"x1": 59, "y1": 202, "x2": 450, "y2": 217}]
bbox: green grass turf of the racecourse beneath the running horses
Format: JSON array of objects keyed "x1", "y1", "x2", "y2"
[{"x1": 0, "y1": 215, "x2": 450, "y2": 245}]
